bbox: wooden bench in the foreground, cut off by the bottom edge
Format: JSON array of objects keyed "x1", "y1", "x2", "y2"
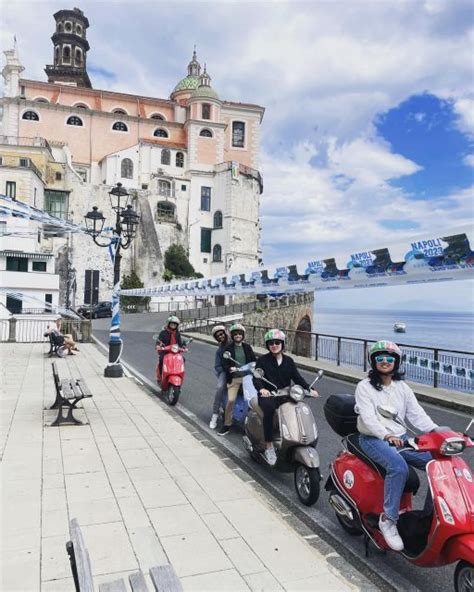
[{"x1": 66, "y1": 518, "x2": 183, "y2": 592}]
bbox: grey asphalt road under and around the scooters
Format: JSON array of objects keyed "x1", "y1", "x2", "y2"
[{"x1": 93, "y1": 314, "x2": 474, "y2": 592}]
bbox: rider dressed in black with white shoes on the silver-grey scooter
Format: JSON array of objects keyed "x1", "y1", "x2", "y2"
[{"x1": 253, "y1": 329, "x2": 318, "y2": 465}]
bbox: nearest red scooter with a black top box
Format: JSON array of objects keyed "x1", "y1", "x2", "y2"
[{"x1": 324, "y1": 395, "x2": 474, "y2": 592}]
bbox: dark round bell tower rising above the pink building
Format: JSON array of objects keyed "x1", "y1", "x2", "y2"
[{"x1": 45, "y1": 8, "x2": 92, "y2": 88}]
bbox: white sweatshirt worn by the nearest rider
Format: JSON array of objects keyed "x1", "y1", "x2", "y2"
[{"x1": 355, "y1": 378, "x2": 437, "y2": 440}]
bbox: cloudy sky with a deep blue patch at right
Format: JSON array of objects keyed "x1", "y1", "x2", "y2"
[{"x1": 0, "y1": 0, "x2": 474, "y2": 310}]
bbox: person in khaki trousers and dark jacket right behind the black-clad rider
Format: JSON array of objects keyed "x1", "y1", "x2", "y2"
[{"x1": 217, "y1": 323, "x2": 257, "y2": 436}]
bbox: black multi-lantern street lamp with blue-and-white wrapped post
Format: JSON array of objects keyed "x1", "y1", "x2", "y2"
[{"x1": 84, "y1": 183, "x2": 140, "y2": 378}]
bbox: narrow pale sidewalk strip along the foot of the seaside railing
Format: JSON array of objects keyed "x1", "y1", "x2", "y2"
[{"x1": 187, "y1": 332, "x2": 474, "y2": 413}]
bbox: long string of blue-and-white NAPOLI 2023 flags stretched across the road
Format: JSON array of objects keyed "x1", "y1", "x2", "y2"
[{"x1": 121, "y1": 228, "x2": 474, "y2": 297}]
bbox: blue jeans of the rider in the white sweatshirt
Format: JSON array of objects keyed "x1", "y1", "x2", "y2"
[{"x1": 359, "y1": 434, "x2": 432, "y2": 521}]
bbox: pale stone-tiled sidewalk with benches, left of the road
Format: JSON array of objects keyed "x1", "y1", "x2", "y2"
[{"x1": 0, "y1": 343, "x2": 376, "y2": 592}]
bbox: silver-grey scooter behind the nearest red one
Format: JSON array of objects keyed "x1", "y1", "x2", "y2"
[{"x1": 243, "y1": 368, "x2": 324, "y2": 506}]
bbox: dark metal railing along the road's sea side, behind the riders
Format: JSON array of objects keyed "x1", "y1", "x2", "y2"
[{"x1": 187, "y1": 319, "x2": 474, "y2": 393}]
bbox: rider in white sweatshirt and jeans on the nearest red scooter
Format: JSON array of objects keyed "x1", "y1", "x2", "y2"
[{"x1": 355, "y1": 341, "x2": 438, "y2": 551}]
